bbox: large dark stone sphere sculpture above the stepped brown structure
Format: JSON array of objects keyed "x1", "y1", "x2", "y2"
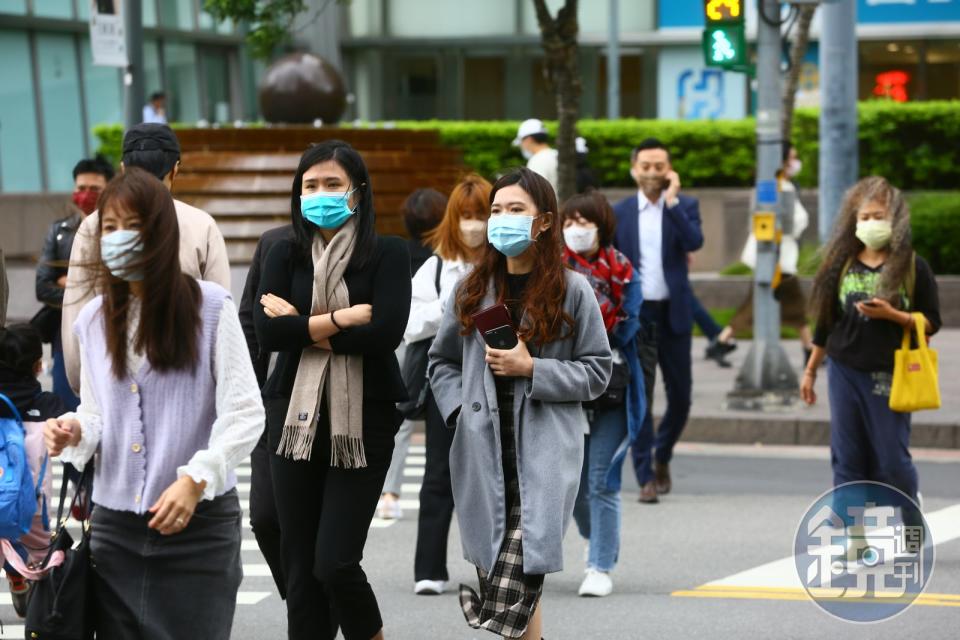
[{"x1": 259, "y1": 53, "x2": 347, "y2": 124}]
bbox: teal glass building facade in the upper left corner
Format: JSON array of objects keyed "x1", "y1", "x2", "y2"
[{"x1": 0, "y1": 0, "x2": 256, "y2": 193}]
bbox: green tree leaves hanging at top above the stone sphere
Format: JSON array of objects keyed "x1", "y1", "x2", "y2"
[{"x1": 203, "y1": 0, "x2": 350, "y2": 60}]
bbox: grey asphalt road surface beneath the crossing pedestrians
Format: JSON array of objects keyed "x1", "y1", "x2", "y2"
[{"x1": 227, "y1": 445, "x2": 960, "y2": 640}]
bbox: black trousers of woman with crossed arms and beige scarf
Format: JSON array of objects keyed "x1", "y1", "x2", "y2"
[{"x1": 266, "y1": 400, "x2": 401, "y2": 640}]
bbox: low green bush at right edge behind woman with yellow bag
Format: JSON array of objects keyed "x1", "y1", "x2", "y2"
[{"x1": 909, "y1": 191, "x2": 960, "y2": 274}]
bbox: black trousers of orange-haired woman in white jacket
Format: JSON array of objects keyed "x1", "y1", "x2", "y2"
[{"x1": 413, "y1": 394, "x2": 454, "y2": 580}]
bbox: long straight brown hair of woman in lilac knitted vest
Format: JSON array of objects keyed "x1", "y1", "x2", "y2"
[{"x1": 94, "y1": 167, "x2": 201, "y2": 379}]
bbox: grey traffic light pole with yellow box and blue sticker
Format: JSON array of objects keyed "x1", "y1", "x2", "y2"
[{"x1": 727, "y1": 0, "x2": 799, "y2": 410}]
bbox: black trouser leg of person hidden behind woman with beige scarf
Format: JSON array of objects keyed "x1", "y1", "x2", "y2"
[{"x1": 250, "y1": 429, "x2": 287, "y2": 598}]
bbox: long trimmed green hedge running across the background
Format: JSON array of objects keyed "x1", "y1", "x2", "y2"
[{"x1": 94, "y1": 102, "x2": 960, "y2": 190}]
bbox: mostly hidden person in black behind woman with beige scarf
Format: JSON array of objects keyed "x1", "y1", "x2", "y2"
[{"x1": 238, "y1": 224, "x2": 294, "y2": 598}]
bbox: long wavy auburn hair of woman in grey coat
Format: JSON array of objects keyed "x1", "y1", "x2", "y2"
[{"x1": 457, "y1": 167, "x2": 573, "y2": 345}]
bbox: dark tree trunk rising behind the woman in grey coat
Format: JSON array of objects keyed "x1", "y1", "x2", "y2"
[{"x1": 533, "y1": 0, "x2": 581, "y2": 204}]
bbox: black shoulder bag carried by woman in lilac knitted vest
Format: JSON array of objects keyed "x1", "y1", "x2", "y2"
[{"x1": 25, "y1": 460, "x2": 95, "y2": 640}]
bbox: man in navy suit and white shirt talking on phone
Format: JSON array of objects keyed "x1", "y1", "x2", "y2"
[{"x1": 614, "y1": 138, "x2": 703, "y2": 503}]
